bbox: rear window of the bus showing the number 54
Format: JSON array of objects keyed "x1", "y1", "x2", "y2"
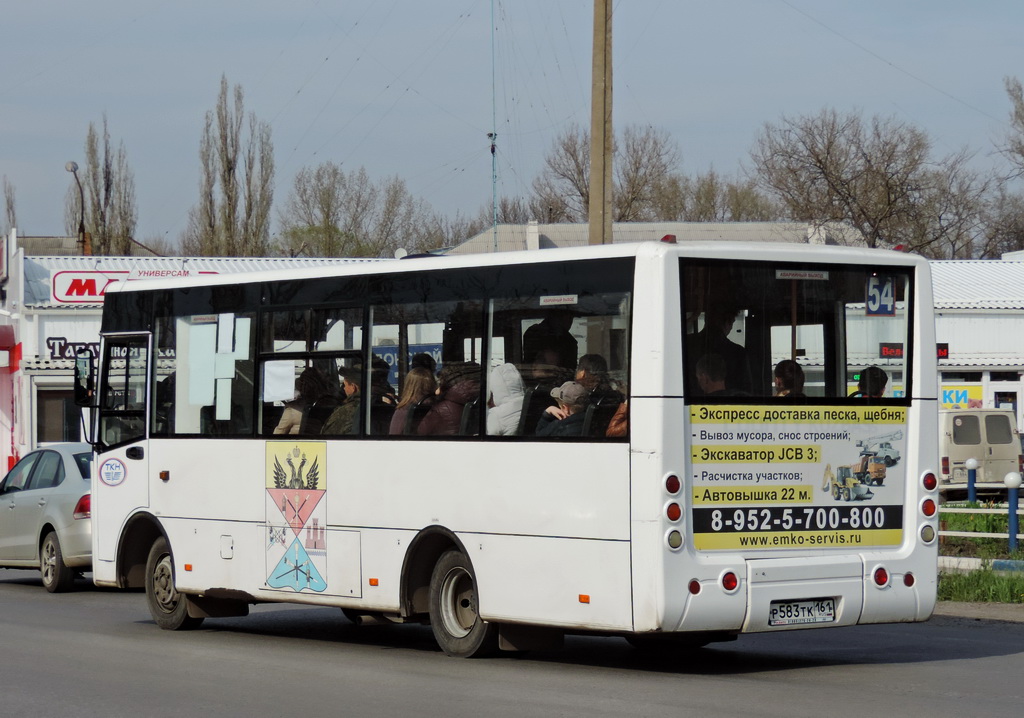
[{"x1": 680, "y1": 259, "x2": 911, "y2": 403}]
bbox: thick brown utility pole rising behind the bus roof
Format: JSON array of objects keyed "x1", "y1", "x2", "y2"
[{"x1": 588, "y1": 0, "x2": 612, "y2": 245}]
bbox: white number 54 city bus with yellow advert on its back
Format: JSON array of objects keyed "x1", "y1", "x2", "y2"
[{"x1": 83, "y1": 242, "x2": 938, "y2": 657}]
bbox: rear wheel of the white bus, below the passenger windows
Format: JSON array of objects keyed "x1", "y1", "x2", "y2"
[{"x1": 430, "y1": 550, "x2": 498, "y2": 659}]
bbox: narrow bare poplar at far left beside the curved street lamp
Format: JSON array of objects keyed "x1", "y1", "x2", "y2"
[{"x1": 65, "y1": 114, "x2": 138, "y2": 255}]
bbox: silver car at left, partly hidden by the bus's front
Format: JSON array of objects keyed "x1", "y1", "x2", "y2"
[{"x1": 0, "y1": 444, "x2": 92, "y2": 593}]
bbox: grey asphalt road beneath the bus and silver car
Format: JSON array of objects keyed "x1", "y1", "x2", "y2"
[{"x1": 0, "y1": 571, "x2": 1024, "y2": 718}]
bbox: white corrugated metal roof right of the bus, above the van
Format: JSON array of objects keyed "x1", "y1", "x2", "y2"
[{"x1": 932, "y1": 259, "x2": 1024, "y2": 310}]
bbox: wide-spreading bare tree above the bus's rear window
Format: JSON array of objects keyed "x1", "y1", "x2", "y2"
[{"x1": 751, "y1": 104, "x2": 991, "y2": 256}]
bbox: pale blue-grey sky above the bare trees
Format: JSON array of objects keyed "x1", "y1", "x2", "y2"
[{"x1": 0, "y1": 0, "x2": 1024, "y2": 246}]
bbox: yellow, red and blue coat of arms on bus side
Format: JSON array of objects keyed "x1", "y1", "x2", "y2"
[{"x1": 264, "y1": 441, "x2": 327, "y2": 592}]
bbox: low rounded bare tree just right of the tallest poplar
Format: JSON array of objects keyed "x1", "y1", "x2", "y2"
[{"x1": 281, "y1": 162, "x2": 440, "y2": 257}]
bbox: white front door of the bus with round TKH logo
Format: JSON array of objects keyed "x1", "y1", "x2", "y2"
[{"x1": 92, "y1": 333, "x2": 153, "y2": 562}]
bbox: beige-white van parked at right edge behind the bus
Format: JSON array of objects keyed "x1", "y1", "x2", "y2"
[{"x1": 939, "y1": 409, "x2": 1024, "y2": 491}]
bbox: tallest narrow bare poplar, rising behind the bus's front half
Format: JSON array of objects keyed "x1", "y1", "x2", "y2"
[{"x1": 181, "y1": 76, "x2": 273, "y2": 257}]
